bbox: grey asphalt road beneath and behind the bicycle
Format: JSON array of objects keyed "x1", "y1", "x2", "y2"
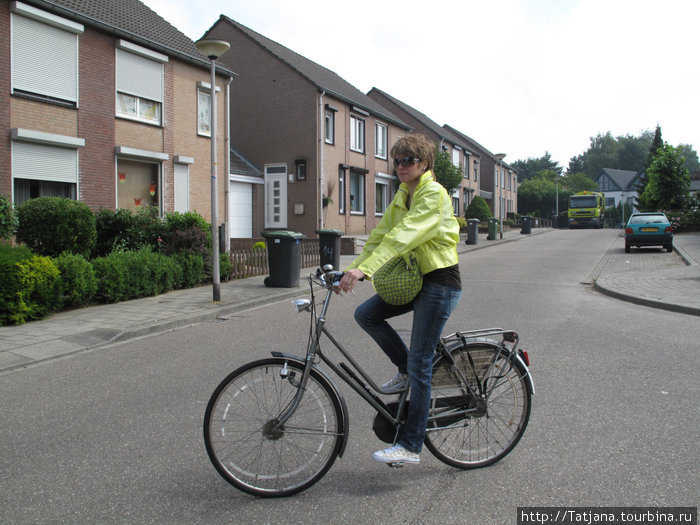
[{"x1": 0, "y1": 230, "x2": 700, "y2": 524}]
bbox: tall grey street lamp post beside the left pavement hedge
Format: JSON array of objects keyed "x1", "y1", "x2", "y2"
[{"x1": 194, "y1": 38, "x2": 231, "y2": 302}]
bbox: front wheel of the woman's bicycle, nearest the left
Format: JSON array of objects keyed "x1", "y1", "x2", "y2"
[{"x1": 204, "y1": 358, "x2": 344, "y2": 497}]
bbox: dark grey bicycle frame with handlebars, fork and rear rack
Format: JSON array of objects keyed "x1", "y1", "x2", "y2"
[{"x1": 272, "y1": 268, "x2": 534, "y2": 438}]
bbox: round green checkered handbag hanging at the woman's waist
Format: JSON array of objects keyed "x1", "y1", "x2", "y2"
[{"x1": 372, "y1": 253, "x2": 423, "y2": 306}]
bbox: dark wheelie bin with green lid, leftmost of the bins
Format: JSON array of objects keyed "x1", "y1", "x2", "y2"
[{"x1": 261, "y1": 230, "x2": 304, "y2": 288}]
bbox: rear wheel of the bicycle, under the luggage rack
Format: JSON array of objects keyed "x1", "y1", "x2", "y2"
[{"x1": 425, "y1": 342, "x2": 532, "y2": 469}]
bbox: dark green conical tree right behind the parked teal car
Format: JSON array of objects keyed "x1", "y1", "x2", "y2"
[{"x1": 641, "y1": 143, "x2": 690, "y2": 210}]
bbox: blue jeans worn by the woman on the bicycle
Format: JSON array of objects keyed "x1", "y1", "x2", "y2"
[{"x1": 355, "y1": 282, "x2": 462, "y2": 452}]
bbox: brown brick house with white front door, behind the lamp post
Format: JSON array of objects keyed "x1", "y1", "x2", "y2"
[{"x1": 205, "y1": 15, "x2": 410, "y2": 237}]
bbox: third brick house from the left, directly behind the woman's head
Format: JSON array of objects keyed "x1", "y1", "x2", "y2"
[{"x1": 367, "y1": 87, "x2": 482, "y2": 217}]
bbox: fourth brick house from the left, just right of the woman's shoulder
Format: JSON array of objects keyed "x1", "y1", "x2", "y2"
[{"x1": 444, "y1": 124, "x2": 518, "y2": 219}]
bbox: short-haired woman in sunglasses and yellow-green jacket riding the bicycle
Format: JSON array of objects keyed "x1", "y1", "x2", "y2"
[{"x1": 340, "y1": 134, "x2": 462, "y2": 463}]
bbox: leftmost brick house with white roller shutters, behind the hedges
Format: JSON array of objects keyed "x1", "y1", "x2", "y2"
[{"x1": 0, "y1": 0, "x2": 235, "y2": 227}]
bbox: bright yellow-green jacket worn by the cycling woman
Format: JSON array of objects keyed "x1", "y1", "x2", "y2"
[{"x1": 347, "y1": 171, "x2": 459, "y2": 277}]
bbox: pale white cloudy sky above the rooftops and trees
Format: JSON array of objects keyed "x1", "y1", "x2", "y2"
[{"x1": 143, "y1": 0, "x2": 700, "y2": 168}]
